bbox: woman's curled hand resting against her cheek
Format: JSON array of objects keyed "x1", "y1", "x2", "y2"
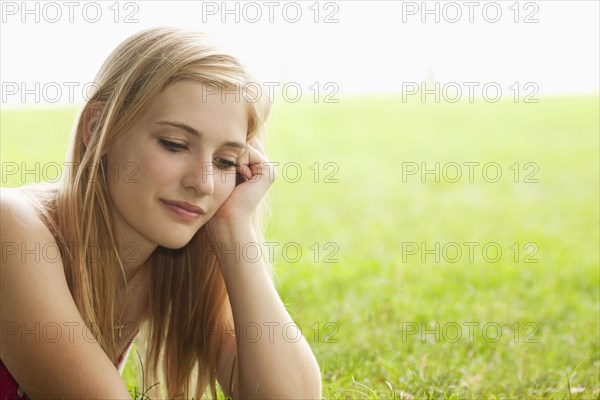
[{"x1": 208, "y1": 138, "x2": 277, "y2": 239}]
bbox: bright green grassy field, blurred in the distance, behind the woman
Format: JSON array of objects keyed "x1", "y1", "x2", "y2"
[{"x1": 0, "y1": 95, "x2": 600, "y2": 399}]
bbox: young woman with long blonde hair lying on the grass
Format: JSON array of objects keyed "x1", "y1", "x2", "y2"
[{"x1": 0, "y1": 28, "x2": 321, "y2": 399}]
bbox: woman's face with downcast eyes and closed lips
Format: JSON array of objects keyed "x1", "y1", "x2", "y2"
[{"x1": 106, "y1": 81, "x2": 248, "y2": 249}]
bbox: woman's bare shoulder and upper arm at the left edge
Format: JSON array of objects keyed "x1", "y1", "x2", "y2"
[{"x1": 0, "y1": 189, "x2": 130, "y2": 398}]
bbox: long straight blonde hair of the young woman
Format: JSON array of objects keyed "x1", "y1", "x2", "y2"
[{"x1": 24, "y1": 28, "x2": 271, "y2": 398}]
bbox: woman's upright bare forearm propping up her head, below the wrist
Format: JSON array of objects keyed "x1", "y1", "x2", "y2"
[{"x1": 216, "y1": 226, "x2": 321, "y2": 399}]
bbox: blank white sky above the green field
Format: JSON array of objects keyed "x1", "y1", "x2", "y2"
[{"x1": 0, "y1": 0, "x2": 600, "y2": 108}]
